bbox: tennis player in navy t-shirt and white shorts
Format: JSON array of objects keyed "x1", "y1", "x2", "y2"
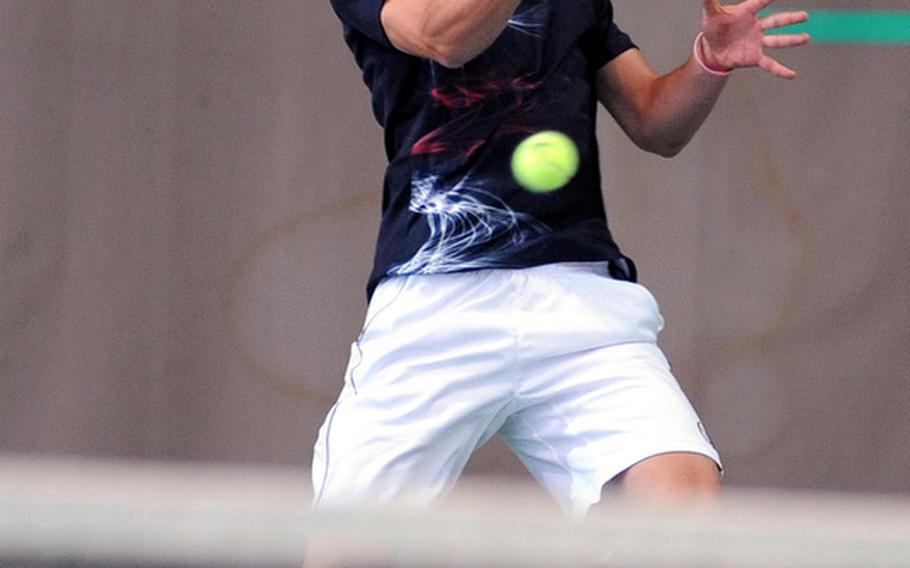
[{"x1": 313, "y1": 0, "x2": 809, "y2": 514}]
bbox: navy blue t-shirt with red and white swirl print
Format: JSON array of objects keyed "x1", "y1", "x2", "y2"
[{"x1": 332, "y1": 0, "x2": 635, "y2": 295}]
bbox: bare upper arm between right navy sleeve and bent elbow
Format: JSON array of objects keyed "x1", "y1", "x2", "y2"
[{"x1": 595, "y1": 49, "x2": 658, "y2": 145}]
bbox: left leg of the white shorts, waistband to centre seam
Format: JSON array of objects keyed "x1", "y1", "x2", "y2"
[{"x1": 313, "y1": 274, "x2": 513, "y2": 506}]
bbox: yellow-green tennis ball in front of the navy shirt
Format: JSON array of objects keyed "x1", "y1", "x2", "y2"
[{"x1": 512, "y1": 130, "x2": 579, "y2": 193}]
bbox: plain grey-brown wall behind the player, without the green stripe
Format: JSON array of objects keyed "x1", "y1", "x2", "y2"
[{"x1": 0, "y1": 0, "x2": 910, "y2": 492}]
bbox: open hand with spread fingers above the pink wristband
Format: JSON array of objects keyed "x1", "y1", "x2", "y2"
[{"x1": 698, "y1": 0, "x2": 809, "y2": 79}]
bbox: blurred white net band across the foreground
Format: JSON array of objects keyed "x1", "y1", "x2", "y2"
[{"x1": 0, "y1": 456, "x2": 910, "y2": 568}]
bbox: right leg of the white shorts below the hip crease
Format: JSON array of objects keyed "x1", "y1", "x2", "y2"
[{"x1": 503, "y1": 343, "x2": 720, "y2": 513}]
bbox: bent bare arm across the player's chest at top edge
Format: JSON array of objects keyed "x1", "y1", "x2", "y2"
[{"x1": 382, "y1": 0, "x2": 521, "y2": 67}]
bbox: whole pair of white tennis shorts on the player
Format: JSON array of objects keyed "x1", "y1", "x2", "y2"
[{"x1": 313, "y1": 263, "x2": 720, "y2": 513}]
